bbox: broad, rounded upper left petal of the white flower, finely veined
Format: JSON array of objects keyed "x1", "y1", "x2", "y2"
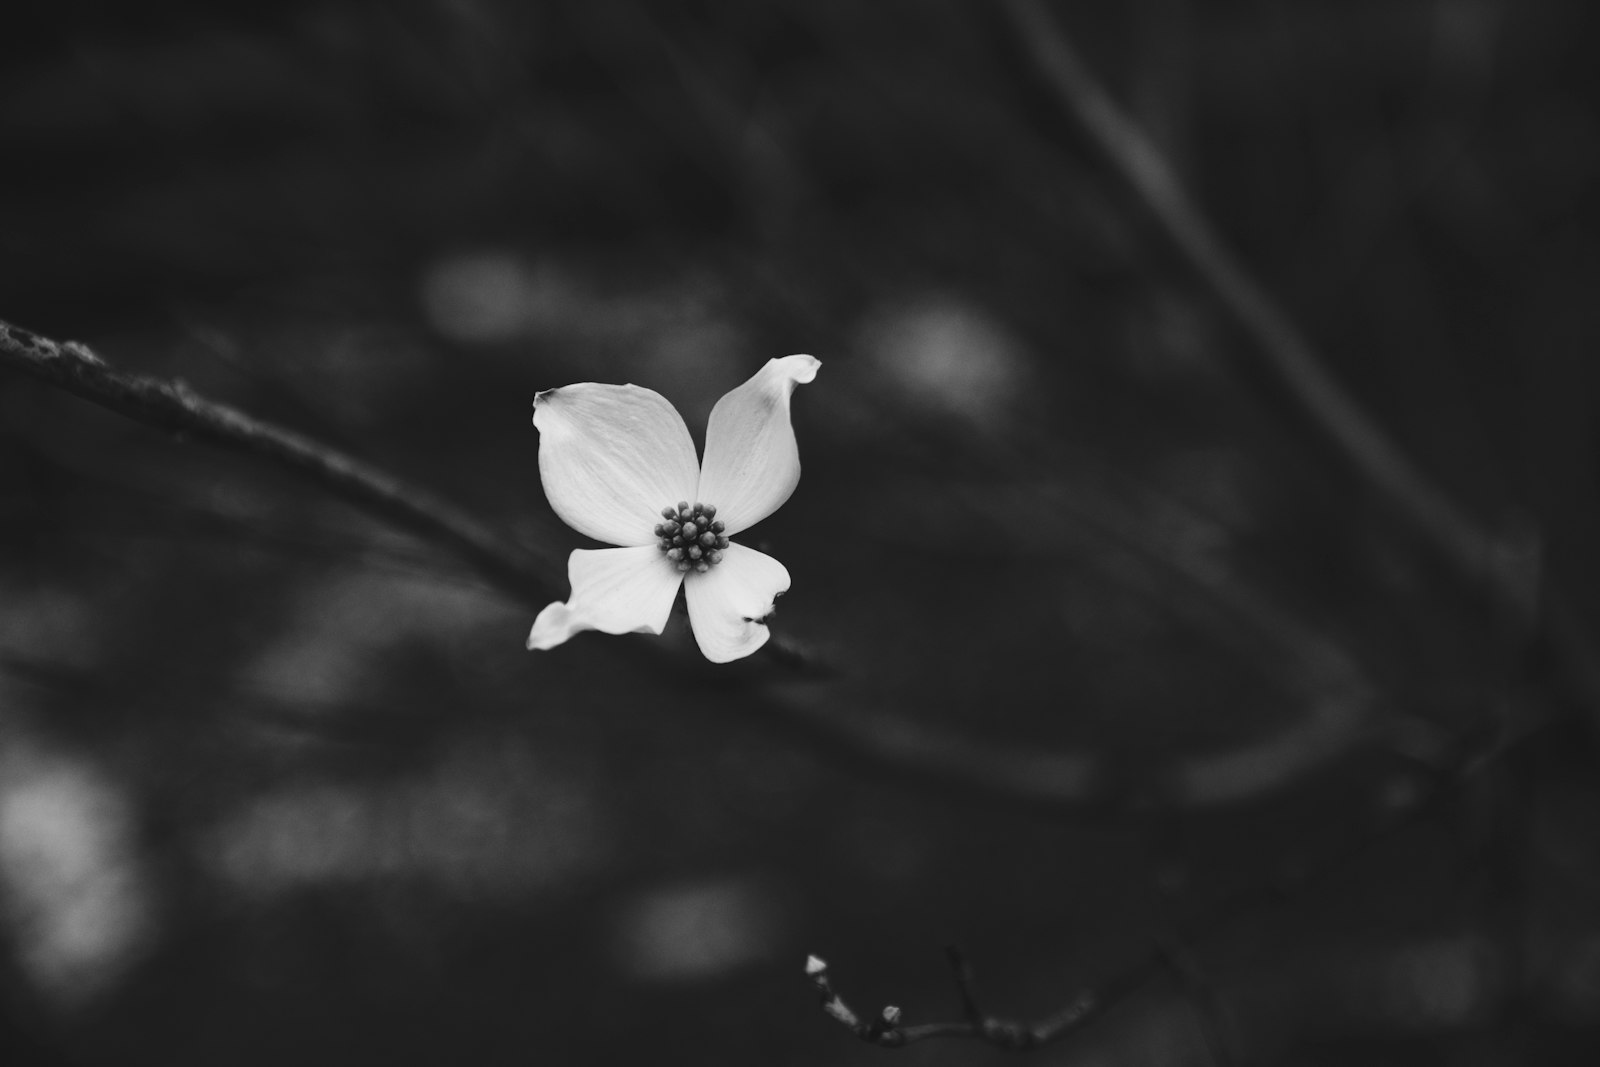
[{"x1": 533, "y1": 382, "x2": 699, "y2": 545}]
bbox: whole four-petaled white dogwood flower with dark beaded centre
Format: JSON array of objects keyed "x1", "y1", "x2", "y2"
[{"x1": 528, "y1": 355, "x2": 821, "y2": 664}]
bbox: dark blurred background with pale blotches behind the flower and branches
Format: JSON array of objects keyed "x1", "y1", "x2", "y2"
[{"x1": 0, "y1": 0, "x2": 1600, "y2": 1067}]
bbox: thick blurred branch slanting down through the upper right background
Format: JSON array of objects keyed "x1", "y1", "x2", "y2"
[{"x1": 998, "y1": 0, "x2": 1600, "y2": 704}]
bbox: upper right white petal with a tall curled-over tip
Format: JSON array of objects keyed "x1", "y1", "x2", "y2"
[{"x1": 694, "y1": 355, "x2": 822, "y2": 534}]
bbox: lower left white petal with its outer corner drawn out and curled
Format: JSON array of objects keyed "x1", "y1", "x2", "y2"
[{"x1": 528, "y1": 544, "x2": 683, "y2": 649}]
